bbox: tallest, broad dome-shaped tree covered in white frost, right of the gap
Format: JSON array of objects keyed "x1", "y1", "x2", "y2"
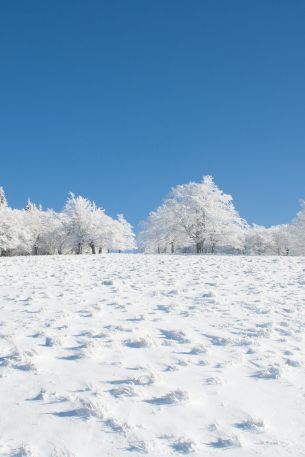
[{"x1": 139, "y1": 176, "x2": 247, "y2": 253}]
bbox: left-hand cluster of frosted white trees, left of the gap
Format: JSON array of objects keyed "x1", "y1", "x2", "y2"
[{"x1": 0, "y1": 188, "x2": 136, "y2": 256}]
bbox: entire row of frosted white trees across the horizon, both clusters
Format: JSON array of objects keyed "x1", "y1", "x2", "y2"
[{"x1": 0, "y1": 176, "x2": 305, "y2": 256}]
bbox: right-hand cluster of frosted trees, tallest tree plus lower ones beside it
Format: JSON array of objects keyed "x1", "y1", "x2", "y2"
[{"x1": 138, "y1": 176, "x2": 305, "y2": 255}]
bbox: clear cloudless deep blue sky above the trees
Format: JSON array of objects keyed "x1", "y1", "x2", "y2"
[{"x1": 0, "y1": 0, "x2": 305, "y2": 225}]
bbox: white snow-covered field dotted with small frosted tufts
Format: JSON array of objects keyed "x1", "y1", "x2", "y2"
[{"x1": 0, "y1": 254, "x2": 305, "y2": 457}]
